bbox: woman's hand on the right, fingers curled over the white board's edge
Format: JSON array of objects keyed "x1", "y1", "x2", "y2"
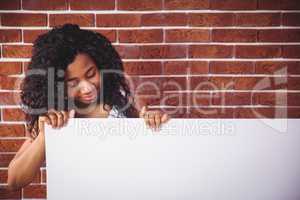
[{"x1": 140, "y1": 106, "x2": 170, "y2": 131}]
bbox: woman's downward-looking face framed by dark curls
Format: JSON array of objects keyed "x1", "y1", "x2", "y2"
[{"x1": 65, "y1": 54, "x2": 101, "y2": 105}]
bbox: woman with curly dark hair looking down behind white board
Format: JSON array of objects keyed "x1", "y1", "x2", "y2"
[{"x1": 8, "y1": 24, "x2": 169, "y2": 190}]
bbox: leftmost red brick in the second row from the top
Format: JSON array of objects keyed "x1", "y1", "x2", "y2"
[{"x1": 1, "y1": 13, "x2": 47, "y2": 26}]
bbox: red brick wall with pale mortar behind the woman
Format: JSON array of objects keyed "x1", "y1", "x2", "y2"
[{"x1": 0, "y1": 0, "x2": 300, "y2": 198}]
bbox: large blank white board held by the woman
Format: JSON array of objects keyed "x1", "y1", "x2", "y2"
[{"x1": 46, "y1": 118, "x2": 300, "y2": 200}]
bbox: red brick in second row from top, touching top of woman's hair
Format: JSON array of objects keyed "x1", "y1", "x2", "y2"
[{"x1": 49, "y1": 14, "x2": 95, "y2": 27}]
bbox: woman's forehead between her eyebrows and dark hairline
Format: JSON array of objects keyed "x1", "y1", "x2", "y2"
[{"x1": 66, "y1": 53, "x2": 95, "y2": 76}]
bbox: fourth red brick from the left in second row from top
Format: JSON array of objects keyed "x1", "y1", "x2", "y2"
[{"x1": 141, "y1": 13, "x2": 187, "y2": 26}]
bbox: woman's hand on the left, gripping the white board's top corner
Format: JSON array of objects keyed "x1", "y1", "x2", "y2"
[{"x1": 38, "y1": 109, "x2": 75, "y2": 132}]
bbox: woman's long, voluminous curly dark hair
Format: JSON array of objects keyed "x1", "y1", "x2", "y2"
[{"x1": 21, "y1": 24, "x2": 138, "y2": 135}]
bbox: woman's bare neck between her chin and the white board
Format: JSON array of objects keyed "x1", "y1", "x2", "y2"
[{"x1": 76, "y1": 103, "x2": 112, "y2": 118}]
